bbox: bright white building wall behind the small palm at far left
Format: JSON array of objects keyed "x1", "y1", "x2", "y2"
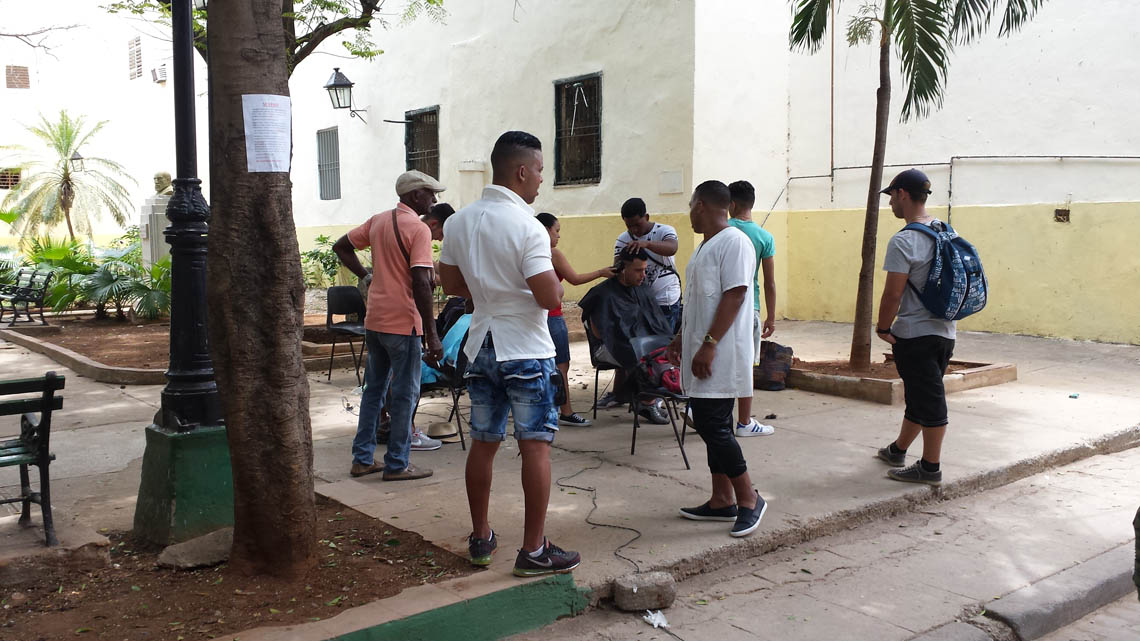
[{"x1": 0, "y1": 0, "x2": 209, "y2": 245}]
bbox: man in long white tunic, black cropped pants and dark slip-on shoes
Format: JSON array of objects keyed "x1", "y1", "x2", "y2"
[{"x1": 669, "y1": 180, "x2": 767, "y2": 537}]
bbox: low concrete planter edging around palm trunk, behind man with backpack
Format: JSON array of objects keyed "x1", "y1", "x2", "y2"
[{"x1": 787, "y1": 357, "x2": 1017, "y2": 405}]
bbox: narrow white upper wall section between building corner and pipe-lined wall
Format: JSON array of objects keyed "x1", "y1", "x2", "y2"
[{"x1": 693, "y1": 0, "x2": 790, "y2": 211}]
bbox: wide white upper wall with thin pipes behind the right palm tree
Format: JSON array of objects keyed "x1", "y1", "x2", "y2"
[{"x1": 787, "y1": 0, "x2": 1140, "y2": 209}]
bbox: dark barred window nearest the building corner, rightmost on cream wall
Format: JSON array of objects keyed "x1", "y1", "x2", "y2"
[{"x1": 554, "y1": 73, "x2": 602, "y2": 185}]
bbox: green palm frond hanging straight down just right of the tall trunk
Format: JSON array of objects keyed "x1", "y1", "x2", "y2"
[{"x1": 887, "y1": 0, "x2": 953, "y2": 122}]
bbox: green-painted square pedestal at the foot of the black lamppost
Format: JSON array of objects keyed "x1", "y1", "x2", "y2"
[{"x1": 135, "y1": 424, "x2": 234, "y2": 544}]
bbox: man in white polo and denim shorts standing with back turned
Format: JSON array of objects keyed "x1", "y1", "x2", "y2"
[{"x1": 439, "y1": 131, "x2": 580, "y2": 576}]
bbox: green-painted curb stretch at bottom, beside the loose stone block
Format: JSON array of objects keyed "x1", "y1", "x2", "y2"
[{"x1": 334, "y1": 574, "x2": 589, "y2": 640}]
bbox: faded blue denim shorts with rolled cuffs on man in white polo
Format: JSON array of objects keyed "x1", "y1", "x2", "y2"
[{"x1": 464, "y1": 334, "x2": 559, "y2": 441}]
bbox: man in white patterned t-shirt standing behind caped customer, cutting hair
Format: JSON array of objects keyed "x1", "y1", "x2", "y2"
[{"x1": 613, "y1": 198, "x2": 681, "y2": 332}]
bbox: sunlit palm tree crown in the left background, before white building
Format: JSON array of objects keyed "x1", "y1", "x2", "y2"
[{"x1": 0, "y1": 111, "x2": 135, "y2": 241}]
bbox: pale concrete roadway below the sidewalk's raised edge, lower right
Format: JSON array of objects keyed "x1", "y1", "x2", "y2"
[{"x1": 516, "y1": 448, "x2": 1140, "y2": 640}]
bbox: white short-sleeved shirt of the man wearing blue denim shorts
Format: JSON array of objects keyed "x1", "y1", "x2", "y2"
[{"x1": 439, "y1": 185, "x2": 554, "y2": 361}]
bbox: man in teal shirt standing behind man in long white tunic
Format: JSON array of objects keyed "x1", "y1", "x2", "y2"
[{"x1": 728, "y1": 180, "x2": 776, "y2": 437}]
